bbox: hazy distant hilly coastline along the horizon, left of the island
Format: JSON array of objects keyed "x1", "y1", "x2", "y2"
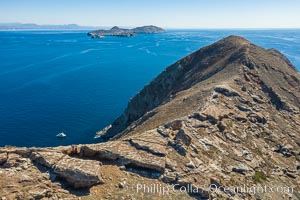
[{"x1": 0, "y1": 23, "x2": 103, "y2": 30}]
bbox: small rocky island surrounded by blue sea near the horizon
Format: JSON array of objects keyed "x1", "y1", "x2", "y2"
[{"x1": 88, "y1": 25, "x2": 166, "y2": 38}]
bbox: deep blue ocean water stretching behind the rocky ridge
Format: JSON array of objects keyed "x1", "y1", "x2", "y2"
[{"x1": 0, "y1": 30, "x2": 300, "y2": 147}]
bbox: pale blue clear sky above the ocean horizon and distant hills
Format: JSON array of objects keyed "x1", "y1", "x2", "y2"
[{"x1": 0, "y1": 0, "x2": 300, "y2": 29}]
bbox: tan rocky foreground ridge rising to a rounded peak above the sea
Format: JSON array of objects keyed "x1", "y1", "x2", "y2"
[{"x1": 0, "y1": 36, "x2": 300, "y2": 199}]
